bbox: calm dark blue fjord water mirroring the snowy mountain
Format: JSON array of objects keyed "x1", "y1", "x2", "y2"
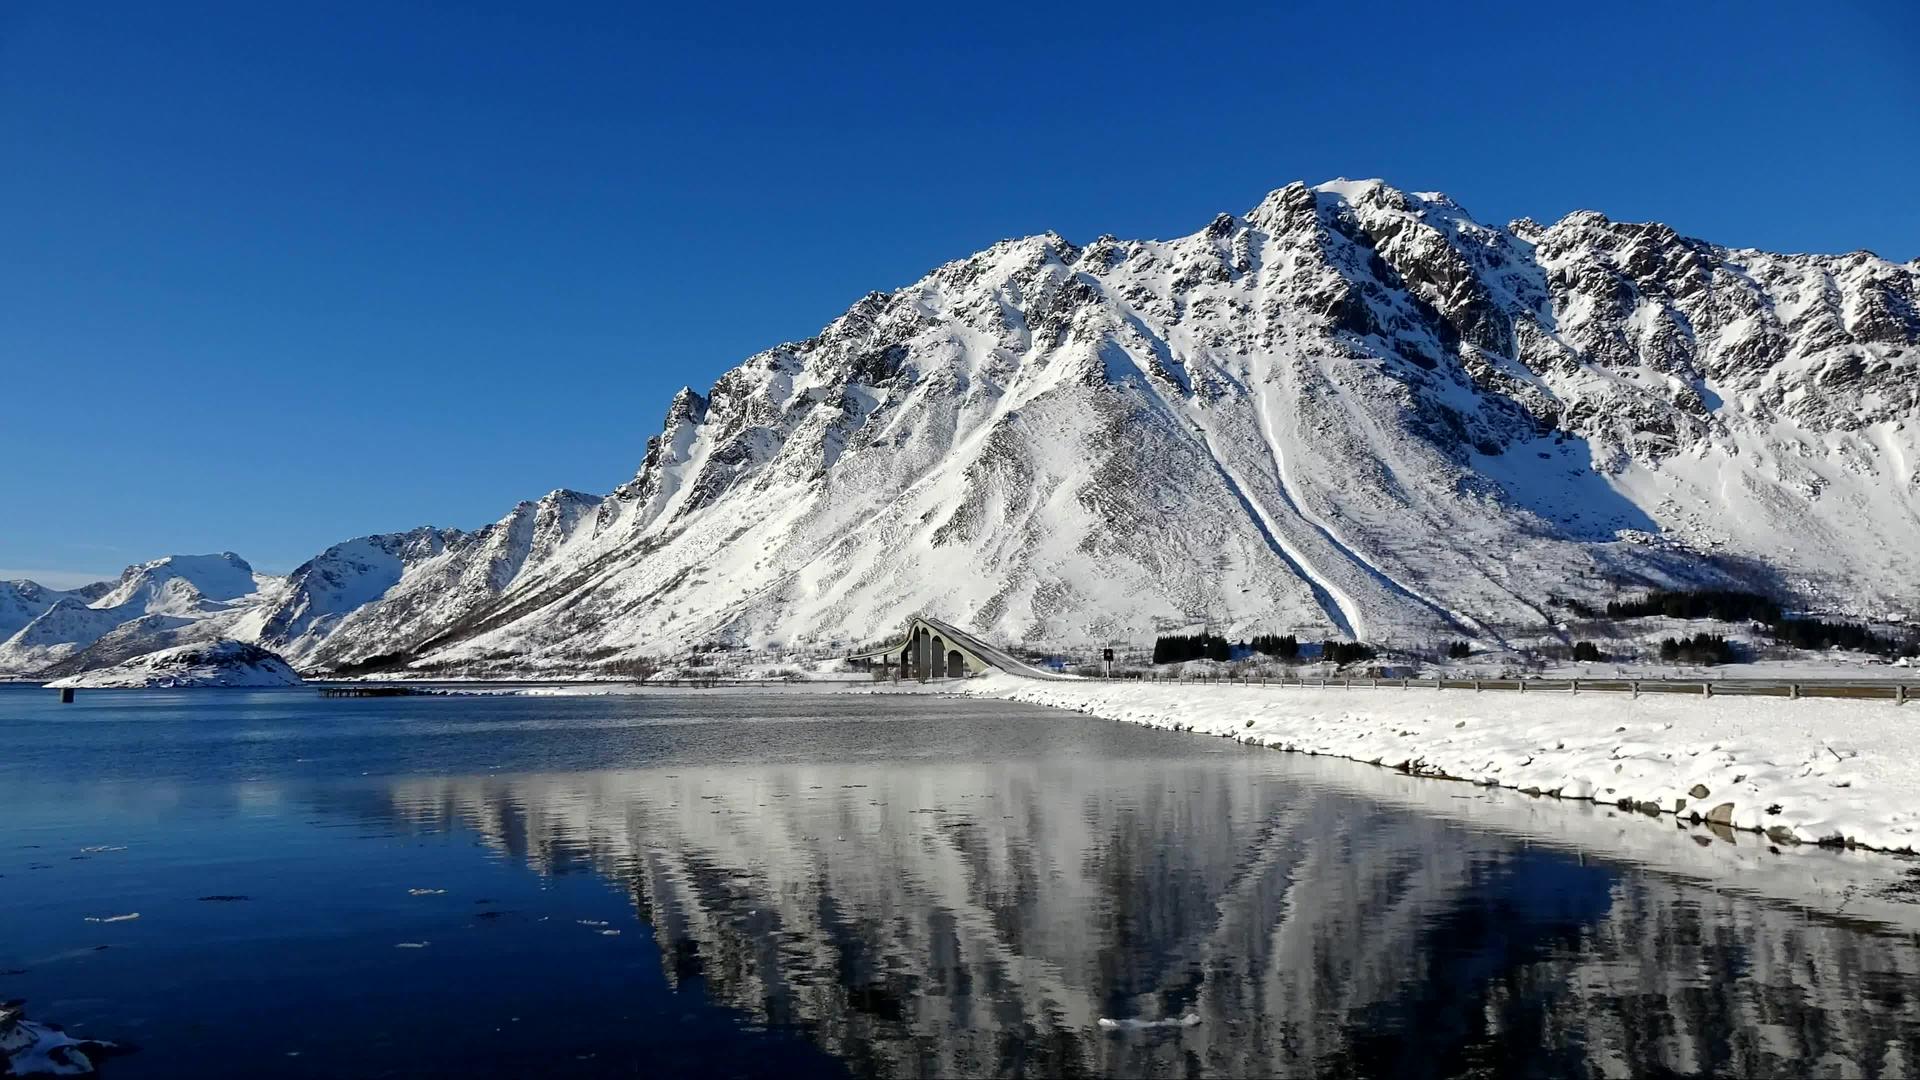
[{"x1": 0, "y1": 688, "x2": 1920, "y2": 1078}]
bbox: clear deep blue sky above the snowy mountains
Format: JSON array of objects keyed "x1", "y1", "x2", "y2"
[{"x1": 0, "y1": 0, "x2": 1920, "y2": 588}]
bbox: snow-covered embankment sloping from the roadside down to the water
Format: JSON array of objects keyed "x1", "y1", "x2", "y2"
[{"x1": 958, "y1": 675, "x2": 1920, "y2": 851}]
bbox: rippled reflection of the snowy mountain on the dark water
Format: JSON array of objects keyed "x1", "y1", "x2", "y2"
[{"x1": 357, "y1": 753, "x2": 1920, "y2": 1076}]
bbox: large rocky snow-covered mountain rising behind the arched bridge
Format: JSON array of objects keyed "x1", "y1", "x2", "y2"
[{"x1": 0, "y1": 181, "x2": 1920, "y2": 669}]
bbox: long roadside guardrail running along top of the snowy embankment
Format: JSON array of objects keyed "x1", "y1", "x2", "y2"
[{"x1": 1114, "y1": 671, "x2": 1920, "y2": 705}]
